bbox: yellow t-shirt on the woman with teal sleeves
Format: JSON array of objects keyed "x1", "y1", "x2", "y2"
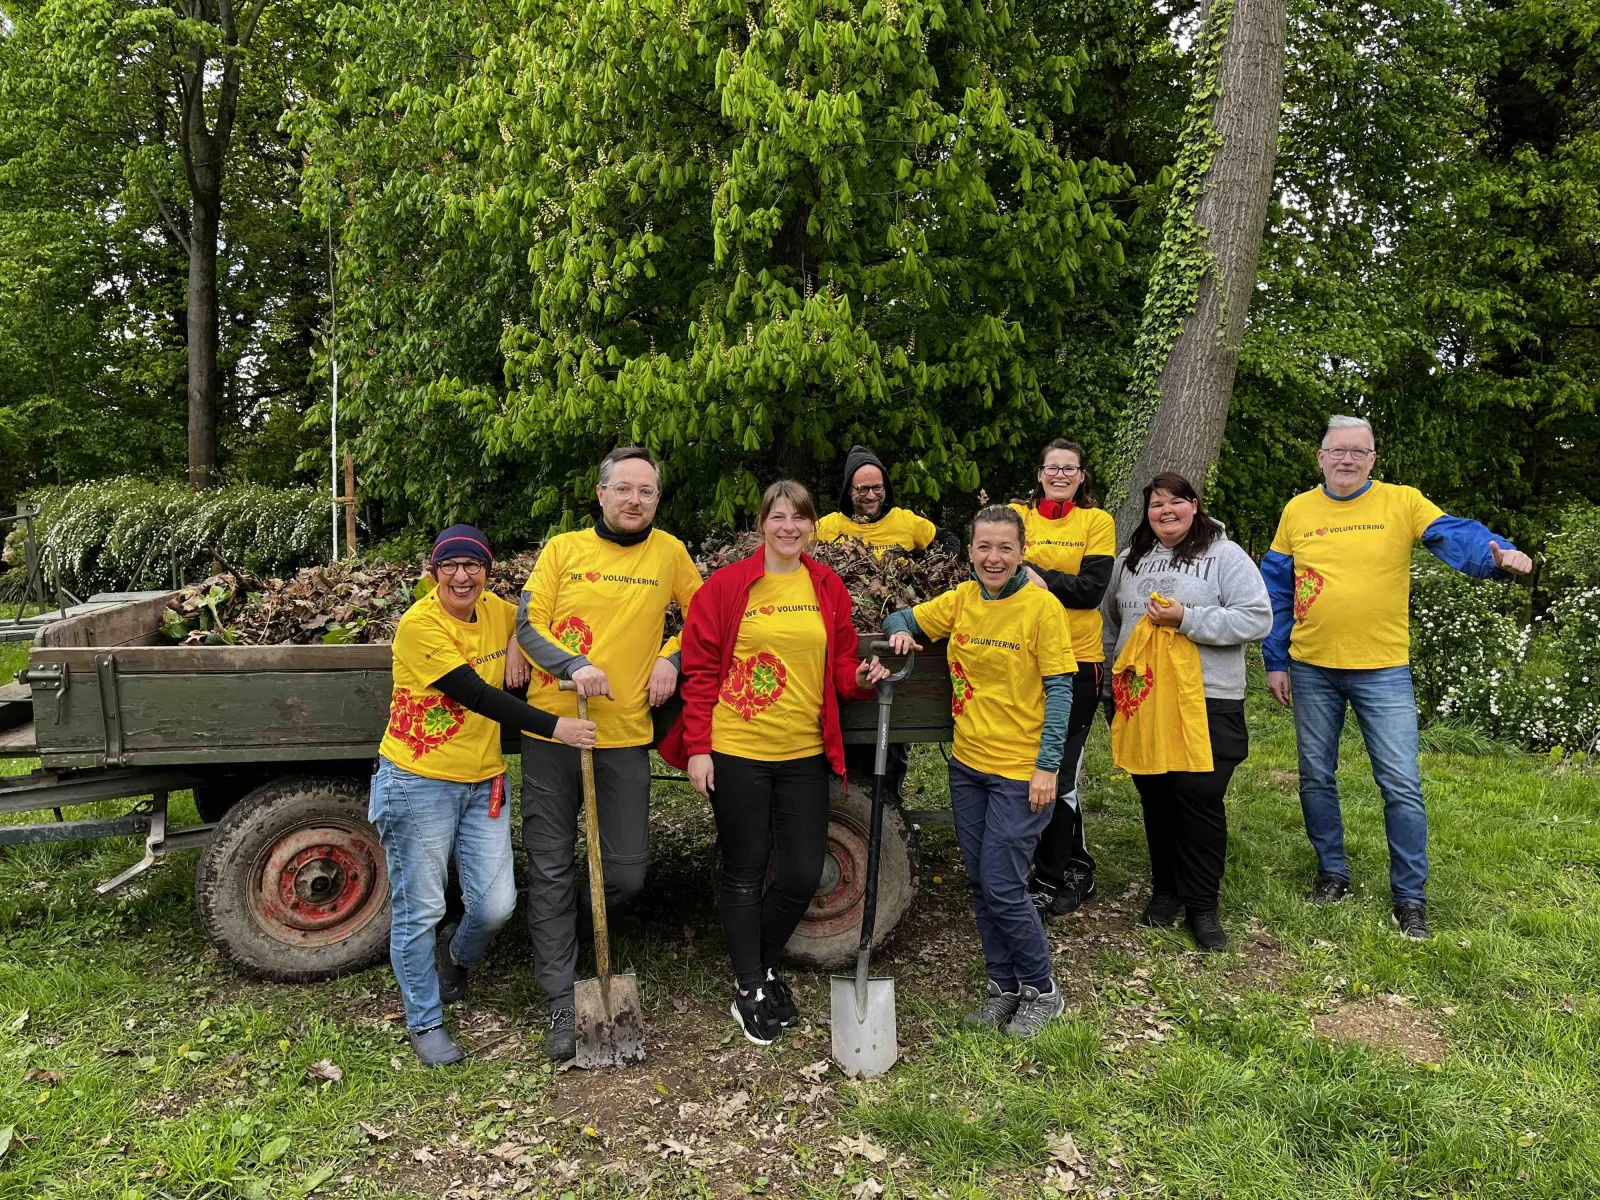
[{"x1": 912, "y1": 579, "x2": 1078, "y2": 779}]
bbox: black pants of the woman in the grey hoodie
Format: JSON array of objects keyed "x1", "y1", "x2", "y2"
[{"x1": 1133, "y1": 699, "x2": 1250, "y2": 917}]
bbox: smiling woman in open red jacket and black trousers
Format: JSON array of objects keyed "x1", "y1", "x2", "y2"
[{"x1": 661, "y1": 480, "x2": 888, "y2": 1046}]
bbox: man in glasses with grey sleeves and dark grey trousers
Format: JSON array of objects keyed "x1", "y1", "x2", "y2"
[{"x1": 517, "y1": 446, "x2": 701, "y2": 1059}]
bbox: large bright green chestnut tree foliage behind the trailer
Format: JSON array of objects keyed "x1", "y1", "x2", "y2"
[{"x1": 298, "y1": 0, "x2": 1130, "y2": 525}]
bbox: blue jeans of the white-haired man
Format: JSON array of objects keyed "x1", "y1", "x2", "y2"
[{"x1": 1290, "y1": 661, "x2": 1427, "y2": 904}]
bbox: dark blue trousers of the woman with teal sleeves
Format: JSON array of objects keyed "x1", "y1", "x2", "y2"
[{"x1": 950, "y1": 758, "x2": 1056, "y2": 992}]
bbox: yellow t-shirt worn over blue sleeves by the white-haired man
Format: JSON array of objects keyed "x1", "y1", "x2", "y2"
[{"x1": 1272, "y1": 480, "x2": 1445, "y2": 670}]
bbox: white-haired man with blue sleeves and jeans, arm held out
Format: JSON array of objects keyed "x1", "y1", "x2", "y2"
[{"x1": 1261, "y1": 416, "x2": 1533, "y2": 939}]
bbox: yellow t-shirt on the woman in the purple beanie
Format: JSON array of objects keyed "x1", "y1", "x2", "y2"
[{"x1": 378, "y1": 590, "x2": 517, "y2": 784}]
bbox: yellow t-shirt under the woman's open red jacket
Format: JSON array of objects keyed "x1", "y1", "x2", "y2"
[{"x1": 710, "y1": 566, "x2": 827, "y2": 763}]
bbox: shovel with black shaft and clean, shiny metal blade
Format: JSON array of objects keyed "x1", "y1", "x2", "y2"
[{"x1": 829, "y1": 642, "x2": 917, "y2": 1077}]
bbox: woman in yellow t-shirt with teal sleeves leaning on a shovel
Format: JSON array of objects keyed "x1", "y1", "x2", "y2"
[{"x1": 883, "y1": 504, "x2": 1077, "y2": 1037}]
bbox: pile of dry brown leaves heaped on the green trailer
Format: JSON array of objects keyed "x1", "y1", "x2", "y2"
[{"x1": 162, "y1": 533, "x2": 968, "y2": 646}]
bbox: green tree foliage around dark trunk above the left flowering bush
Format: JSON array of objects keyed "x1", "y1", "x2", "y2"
[{"x1": 0, "y1": 0, "x2": 326, "y2": 507}]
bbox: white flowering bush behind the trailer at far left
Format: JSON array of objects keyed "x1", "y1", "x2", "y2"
[{"x1": 6, "y1": 477, "x2": 330, "y2": 595}]
